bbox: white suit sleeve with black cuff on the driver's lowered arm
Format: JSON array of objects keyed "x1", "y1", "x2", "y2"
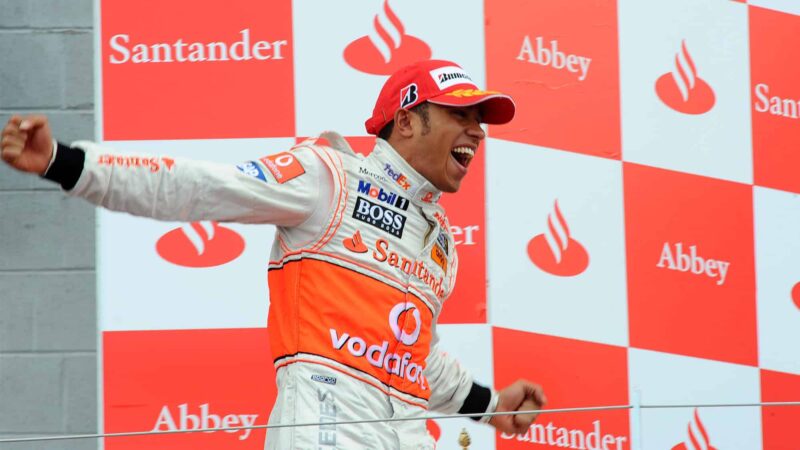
[{"x1": 425, "y1": 332, "x2": 498, "y2": 422}]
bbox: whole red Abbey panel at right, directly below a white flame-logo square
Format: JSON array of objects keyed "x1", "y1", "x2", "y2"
[{"x1": 623, "y1": 163, "x2": 758, "y2": 365}]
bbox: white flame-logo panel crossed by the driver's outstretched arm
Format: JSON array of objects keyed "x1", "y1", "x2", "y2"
[{"x1": 97, "y1": 139, "x2": 294, "y2": 330}]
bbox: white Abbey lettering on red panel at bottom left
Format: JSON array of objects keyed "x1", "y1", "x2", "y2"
[{"x1": 153, "y1": 403, "x2": 258, "y2": 441}]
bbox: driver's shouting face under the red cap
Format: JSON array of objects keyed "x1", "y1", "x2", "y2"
[{"x1": 409, "y1": 103, "x2": 486, "y2": 192}]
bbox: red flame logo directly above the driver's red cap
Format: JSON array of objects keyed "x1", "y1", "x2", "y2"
[{"x1": 344, "y1": 0, "x2": 431, "y2": 75}]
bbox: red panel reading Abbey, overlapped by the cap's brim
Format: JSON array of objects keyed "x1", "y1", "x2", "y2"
[{"x1": 486, "y1": 0, "x2": 620, "y2": 159}]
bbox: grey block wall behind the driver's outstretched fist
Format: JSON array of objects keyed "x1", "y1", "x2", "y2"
[{"x1": 0, "y1": 0, "x2": 98, "y2": 450}]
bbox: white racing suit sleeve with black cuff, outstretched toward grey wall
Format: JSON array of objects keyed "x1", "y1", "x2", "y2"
[{"x1": 44, "y1": 141, "x2": 326, "y2": 226}]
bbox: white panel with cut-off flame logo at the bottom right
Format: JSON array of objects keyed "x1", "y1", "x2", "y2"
[{"x1": 628, "y1": 348, "x2": 760, "y2": 450}]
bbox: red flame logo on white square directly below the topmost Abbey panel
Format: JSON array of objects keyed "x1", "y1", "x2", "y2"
[{"x1": 528, "y1": 200, "x2": 589, "y2": 277}]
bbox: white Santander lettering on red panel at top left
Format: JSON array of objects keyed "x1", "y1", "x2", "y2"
[{"x1": 108, "y1": 28, "x2": 289, "y2": 64}]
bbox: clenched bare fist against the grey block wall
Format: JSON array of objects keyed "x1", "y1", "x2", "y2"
[{"x1": 0, "y1": 116, "x2": 53, "y2": 175}]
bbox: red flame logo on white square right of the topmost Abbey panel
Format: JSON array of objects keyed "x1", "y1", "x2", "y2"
[{"x1": 656, "y1": 40, "x2": 716, "y2": 114}]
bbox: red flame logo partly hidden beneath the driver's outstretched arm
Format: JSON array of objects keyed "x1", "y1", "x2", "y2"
[{"x1": 156, "y1": 221, "x2": 244, "y2": 267}]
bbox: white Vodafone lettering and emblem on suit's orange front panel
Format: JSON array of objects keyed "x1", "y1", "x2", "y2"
[{"x1": 330, "y1": 303, "x2": 428, "y2": 390}]
